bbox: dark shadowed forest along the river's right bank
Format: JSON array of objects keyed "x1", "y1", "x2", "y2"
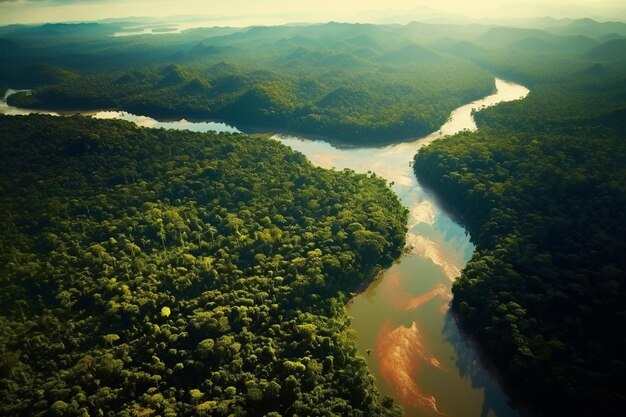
[{"x1": 414, "y1": 31, "x2": 626, "y2": 416}]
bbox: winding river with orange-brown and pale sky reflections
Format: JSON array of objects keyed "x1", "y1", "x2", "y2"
[{"x1": 0, "y1": 79, "x2": 528, "y2": 417}]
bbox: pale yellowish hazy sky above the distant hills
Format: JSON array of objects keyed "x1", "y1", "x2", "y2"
[{"x1": 0, "y1": 0, "x2": 626, "y2": 26}]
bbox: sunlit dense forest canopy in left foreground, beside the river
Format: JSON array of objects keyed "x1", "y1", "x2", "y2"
[{"x1": 0, "y1": 115, "x2": 406, "y2": 417}]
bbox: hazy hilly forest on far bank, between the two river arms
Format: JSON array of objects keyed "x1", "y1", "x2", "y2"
[{"x1": 0, "y1": 23, "x2": 494, "y2": 143}]
